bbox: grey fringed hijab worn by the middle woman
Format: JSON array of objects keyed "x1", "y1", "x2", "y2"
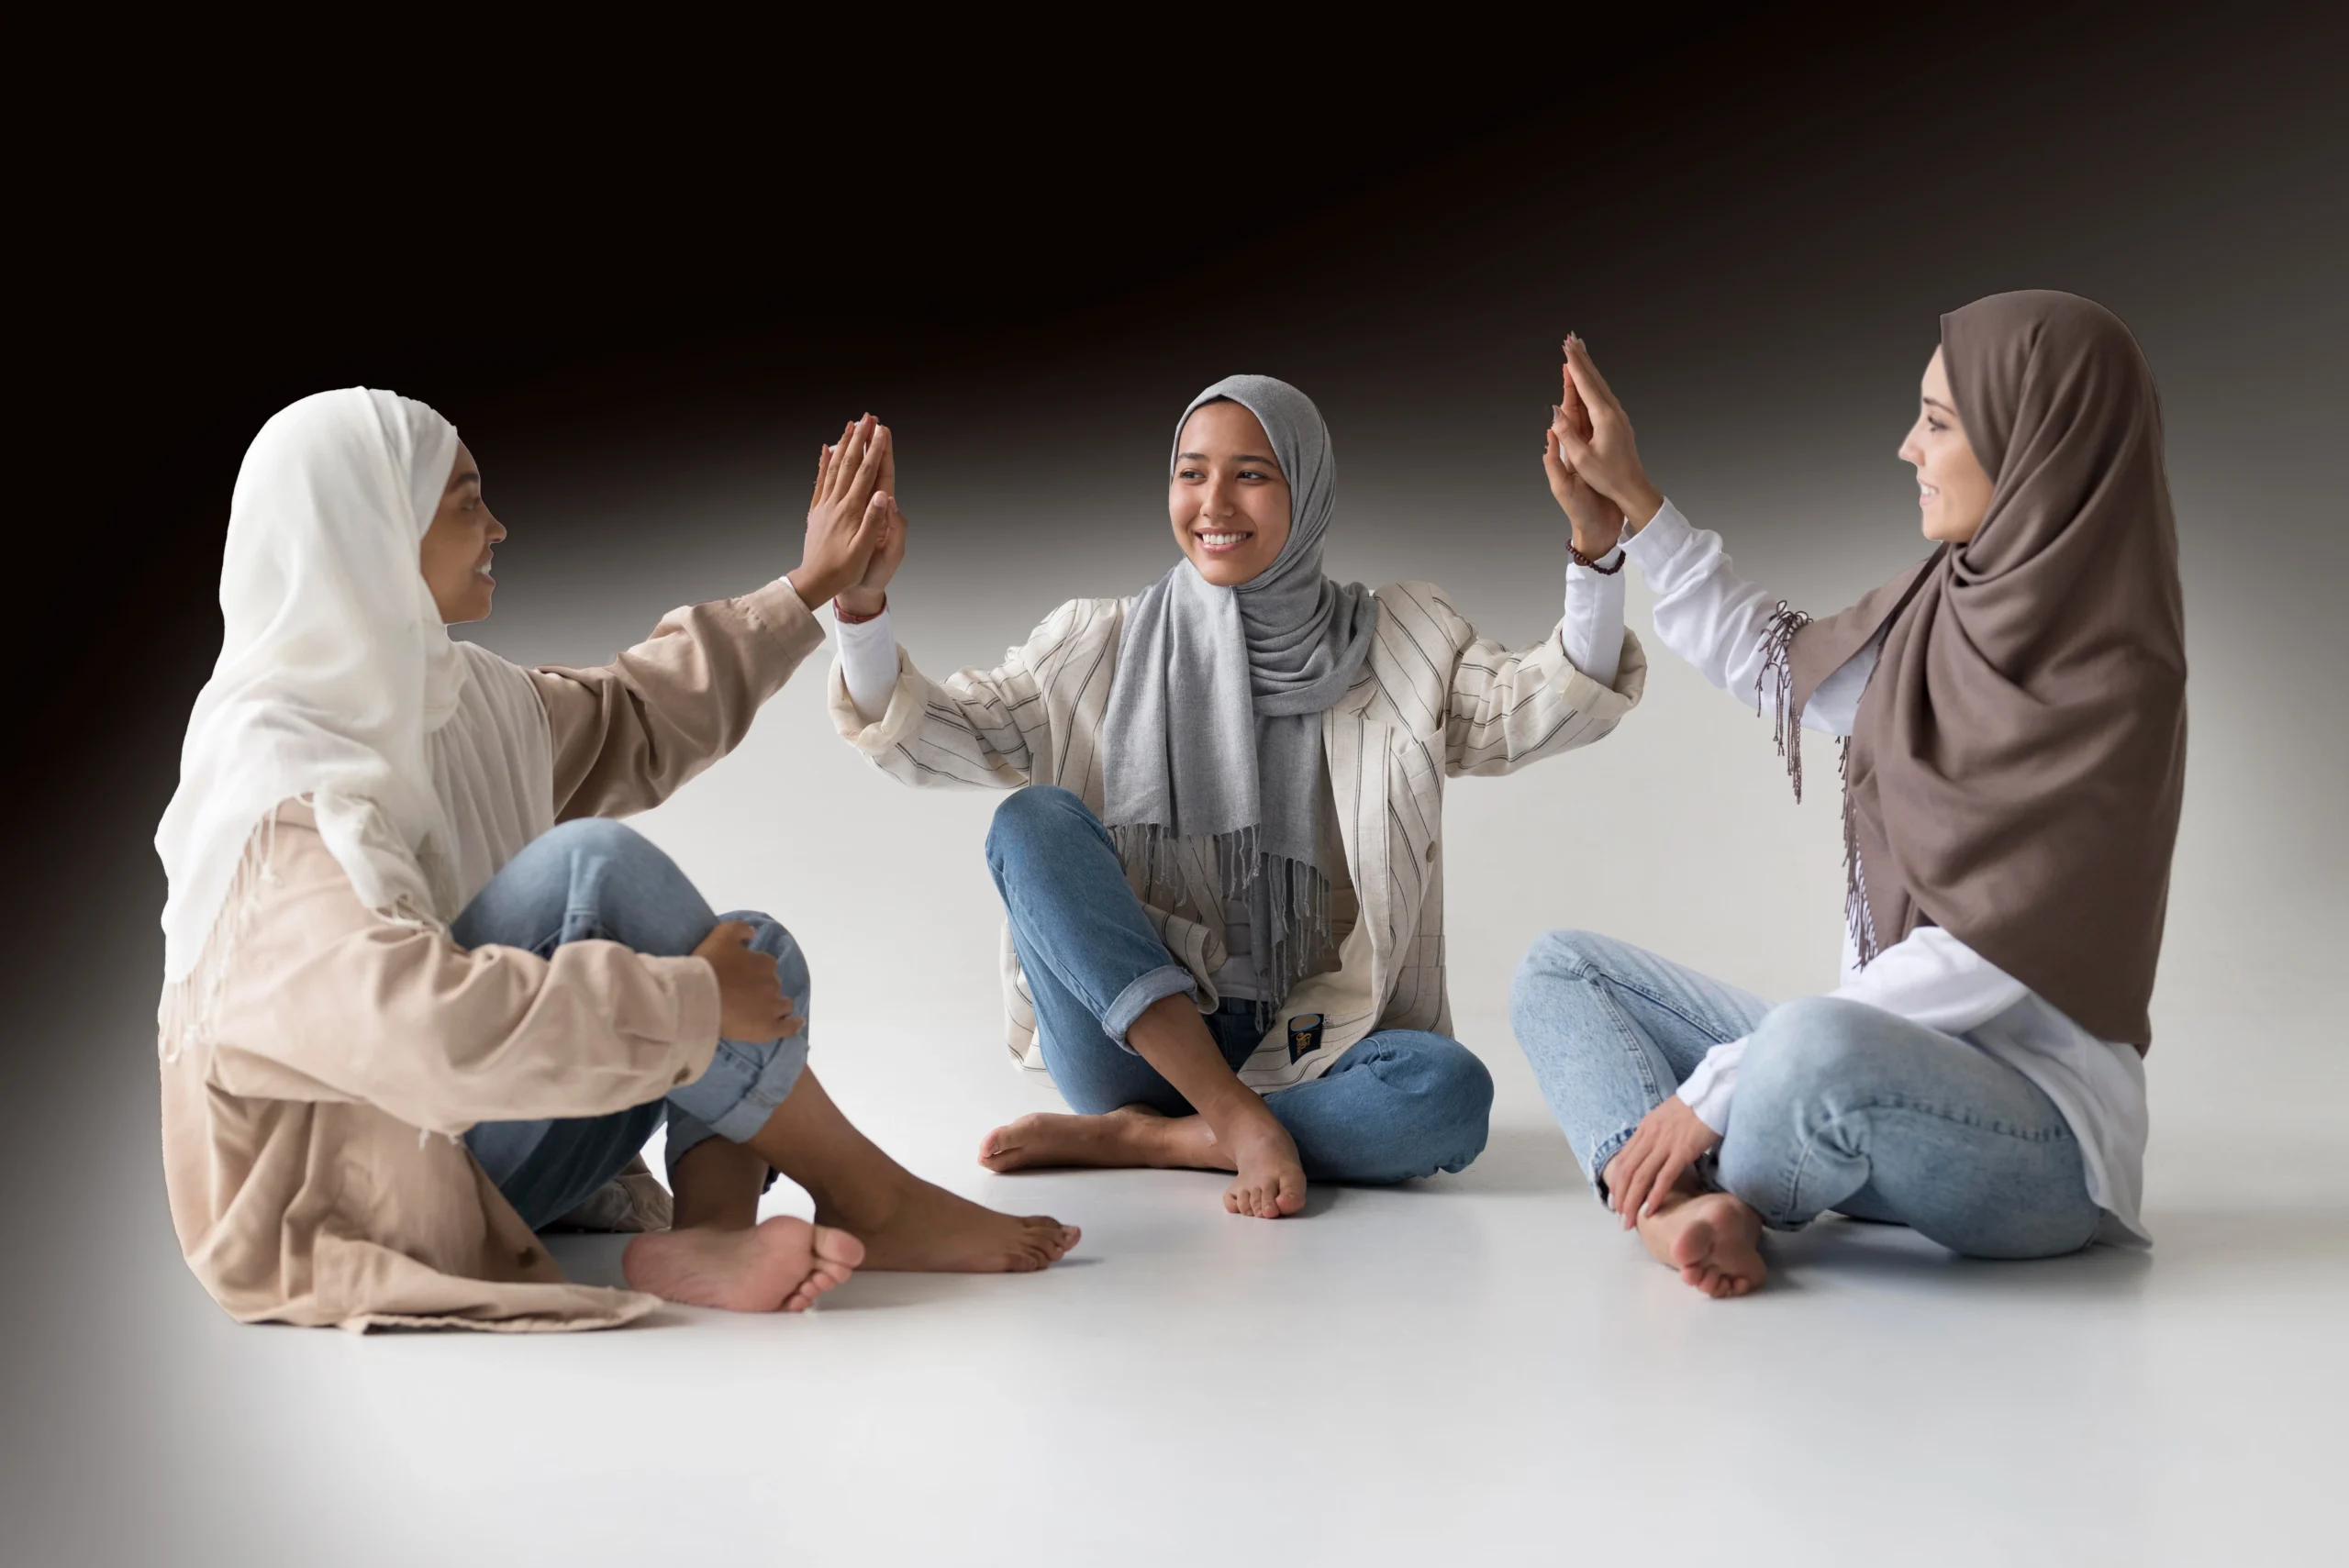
[{"x1": 1102, "y1": 375, "x2": 1379, "y2": 995}]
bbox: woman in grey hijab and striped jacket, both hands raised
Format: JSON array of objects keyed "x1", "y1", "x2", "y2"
[{"x1": 831, "y1": 375, "x2": 1644, "y2": 1218}]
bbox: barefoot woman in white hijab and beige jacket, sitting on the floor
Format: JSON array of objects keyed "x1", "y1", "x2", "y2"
[{"x1": 155, "y1": 387, "x2": 1075, "y2": 1329}]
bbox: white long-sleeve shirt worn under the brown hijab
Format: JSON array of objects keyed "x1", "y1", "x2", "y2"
[{"x1": 1623, "y1": 502, "x2": 2149, "y2": 1244}]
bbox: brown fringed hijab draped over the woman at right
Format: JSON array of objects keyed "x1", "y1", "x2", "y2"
[{"x1": 1780, "y1": 289, "x2": 2187, "y2": 1051}]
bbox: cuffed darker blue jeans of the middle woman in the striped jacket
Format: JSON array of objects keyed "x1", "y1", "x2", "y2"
[{"x1": 986, "y1": 784, "x2": 1492, "y2": 1181}]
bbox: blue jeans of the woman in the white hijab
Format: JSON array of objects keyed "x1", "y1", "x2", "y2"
[{"x1": 449, "y1": 817, "x2": 808, "y2": 1230}]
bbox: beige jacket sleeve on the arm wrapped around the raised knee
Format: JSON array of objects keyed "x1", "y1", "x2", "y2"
[{"x1": 205, "y1": 803, "x2": 721, "y2": 1134}]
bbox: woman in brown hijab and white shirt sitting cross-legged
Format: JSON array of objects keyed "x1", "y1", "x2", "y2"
[{"x1": 1513, "y1": 291, "x2": 2187, "y2": 1296}]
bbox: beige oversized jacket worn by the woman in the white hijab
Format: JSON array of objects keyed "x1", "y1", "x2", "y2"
[{"x1": 162, "y1": 582, "x2": 822, "y2": 1331}]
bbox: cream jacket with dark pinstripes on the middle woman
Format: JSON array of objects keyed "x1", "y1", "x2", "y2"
[{"x1": 829, "y1": 582, "x2": 1647, "y2": 1092}]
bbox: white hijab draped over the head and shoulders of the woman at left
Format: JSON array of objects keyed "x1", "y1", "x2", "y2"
[{"x1": 155, "y1": 387, "x2": 554, "y2": 985}]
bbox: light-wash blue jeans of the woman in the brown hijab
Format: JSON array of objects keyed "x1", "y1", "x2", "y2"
[{"x1": 1510, "y1": 932, "x2": 2102, "y2": 1258}]
